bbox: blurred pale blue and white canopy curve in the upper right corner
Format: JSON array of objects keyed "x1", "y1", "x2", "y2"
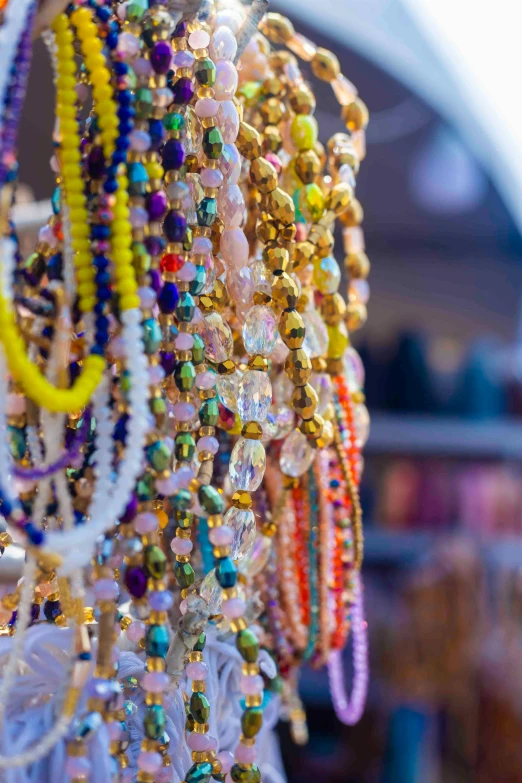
[{"x1": 277, "y1": 0, "x2": 522, "y2": 233}]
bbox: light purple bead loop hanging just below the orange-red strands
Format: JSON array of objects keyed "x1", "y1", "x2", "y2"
[{"x1": 328, "y1": 574, "x2": 369, "y2": 726}]
